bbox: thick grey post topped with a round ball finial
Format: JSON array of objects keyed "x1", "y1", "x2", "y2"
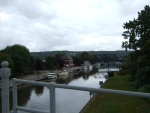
[{"x1": 0, "y1": 61, "x2": 10, "y2": 113}]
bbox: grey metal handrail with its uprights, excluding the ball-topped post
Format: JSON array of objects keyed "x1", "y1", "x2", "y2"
[{"x1": 12, "y1": 78, "x2": 150, "y2": 113}]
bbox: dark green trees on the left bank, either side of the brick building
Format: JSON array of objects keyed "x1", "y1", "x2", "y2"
[{"x1": 0, "y1": 44, "x2": 101, "y2": 78}]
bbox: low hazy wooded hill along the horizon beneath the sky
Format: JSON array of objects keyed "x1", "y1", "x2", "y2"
[{"x1": 31, "y1": 50, "x2": 132, "y2": 59}]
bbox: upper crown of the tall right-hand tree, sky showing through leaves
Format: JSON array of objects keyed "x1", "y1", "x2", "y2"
[{"x1": 122, "y1": 5, "x2": 150, "y2": 50}]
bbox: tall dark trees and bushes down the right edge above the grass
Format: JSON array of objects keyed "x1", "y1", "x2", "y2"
[{"x1": 122, "y1": 5, "x2": 150, "y2": 92}]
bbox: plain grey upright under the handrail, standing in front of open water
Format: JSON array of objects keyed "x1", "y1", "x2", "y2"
[{"x1": 50, "y1": 82, "x2": 56, "y2": 113}]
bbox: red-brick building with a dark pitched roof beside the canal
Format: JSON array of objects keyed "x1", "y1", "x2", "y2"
[{"x1": 61, "y1": 55, "x2": 74, "y2": 67}]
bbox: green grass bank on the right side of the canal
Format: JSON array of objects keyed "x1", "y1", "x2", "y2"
[{"x1": 83, "y1": 75, "x2": 150, "y2": 113}]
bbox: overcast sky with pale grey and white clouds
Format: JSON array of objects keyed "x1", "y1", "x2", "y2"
[{"x1": 0, "y1": 0, "x2": 150, "y2": 52}]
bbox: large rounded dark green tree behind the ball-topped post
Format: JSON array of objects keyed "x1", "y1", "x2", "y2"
[{"x1": 1, "y1": 44, "x2": 34, "y2": 77}]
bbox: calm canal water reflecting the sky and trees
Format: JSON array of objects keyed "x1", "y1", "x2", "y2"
[{"x1": 0, "y1": 69, "x2": 118, "y2": 113}]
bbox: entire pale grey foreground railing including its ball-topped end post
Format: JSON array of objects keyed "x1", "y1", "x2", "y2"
[{"x1": 0, "y1": 62, "x2": 150, "y2": 113}]
